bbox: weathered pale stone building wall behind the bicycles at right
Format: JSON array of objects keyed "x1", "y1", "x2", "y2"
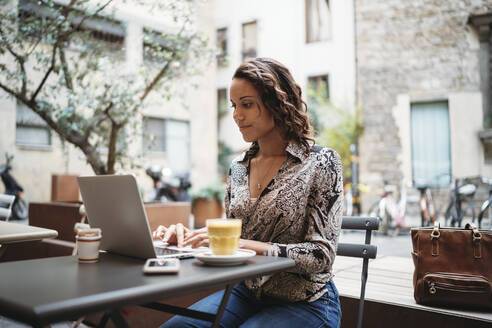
[{"x1": 354, "y1": 0, "x2": 492, "y2": 210}]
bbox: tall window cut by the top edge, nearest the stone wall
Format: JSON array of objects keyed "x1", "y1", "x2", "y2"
[{"x1": 305, "y1": 0, "x2": 331, "y2": 43}]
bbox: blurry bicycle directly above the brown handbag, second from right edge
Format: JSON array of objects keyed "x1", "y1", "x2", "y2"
[{"x1": 444, "y1": 178, "x2": 477, "y2": 227}]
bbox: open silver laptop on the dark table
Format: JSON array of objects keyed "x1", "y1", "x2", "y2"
[{"x1": 77, "y1": 175, "x2": 194, "y2": 259}]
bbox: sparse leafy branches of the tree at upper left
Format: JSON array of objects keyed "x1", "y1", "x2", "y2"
[{"x1": 0, "y1": 0, "x2": 208, "y2": 174}]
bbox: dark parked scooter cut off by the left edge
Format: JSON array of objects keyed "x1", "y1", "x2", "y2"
[{"x1": 0, "y1": 154, "x2": 28, "y2": 220}]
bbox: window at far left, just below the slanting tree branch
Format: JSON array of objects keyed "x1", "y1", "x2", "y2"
[{"x1": 15, "y1": 104, "x2": 51, "y2": 147}]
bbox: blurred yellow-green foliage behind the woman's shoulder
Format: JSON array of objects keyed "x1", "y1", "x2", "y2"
[{"x1": 308, "y1": 81, "x2": 364, "y2": 180}]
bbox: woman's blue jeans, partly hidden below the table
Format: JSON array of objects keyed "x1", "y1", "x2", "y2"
[{"x1": 161, "y1": 281, "x2": 342, "y2": 328}]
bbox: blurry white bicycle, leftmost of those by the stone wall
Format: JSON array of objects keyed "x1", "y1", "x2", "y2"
[{"x1": 369, "y1": 182, "x2": 407, "y2": 235}]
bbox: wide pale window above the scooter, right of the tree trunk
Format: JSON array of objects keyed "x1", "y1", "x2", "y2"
[{"x1": 143, "y1": 117, "x2": 190, "y2": 174}]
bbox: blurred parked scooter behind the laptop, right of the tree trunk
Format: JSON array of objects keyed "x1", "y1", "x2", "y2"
[{"x1": 145, "y1": 165, "x2": 191, "y2": 202}]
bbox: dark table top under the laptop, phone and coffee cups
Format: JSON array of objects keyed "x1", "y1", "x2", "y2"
[{"x1": 0, "y1": 254, "x2": 294, "y2": 325}]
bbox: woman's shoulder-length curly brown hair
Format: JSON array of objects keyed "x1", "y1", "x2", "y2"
[{"x1": 232, "y1": 58, "x2": 314, "y2": 152}]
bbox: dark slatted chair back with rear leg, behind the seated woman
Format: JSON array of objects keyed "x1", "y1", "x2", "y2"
[{"x1": 337, "y1": 216, "x2": 380, "y2": 328}]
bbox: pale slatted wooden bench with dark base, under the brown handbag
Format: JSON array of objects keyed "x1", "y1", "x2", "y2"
[{"x1": 333, "y1": 227, "x2": 492, "y2": 328}]
